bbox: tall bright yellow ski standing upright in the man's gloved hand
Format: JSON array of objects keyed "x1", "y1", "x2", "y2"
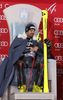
[{"x1": 42, "y1": 10, "x2": 49, "y2": 92}]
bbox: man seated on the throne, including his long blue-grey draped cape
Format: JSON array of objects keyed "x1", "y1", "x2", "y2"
[{"x1": 0, "y1": 23, "x2": 51, "y2": 97}]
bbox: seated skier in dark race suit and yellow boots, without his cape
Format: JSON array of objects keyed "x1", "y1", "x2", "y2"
[{"x1": 16, "y1": 23, "x2": 51, "y2": 92}]
